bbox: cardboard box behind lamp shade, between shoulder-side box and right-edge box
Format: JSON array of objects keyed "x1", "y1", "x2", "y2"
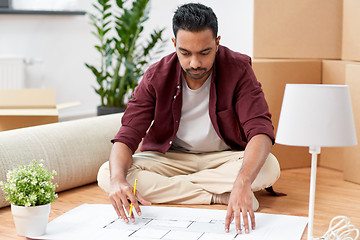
[{"x1": 318, "y1": 60, "x2": 360, "y2": 171}]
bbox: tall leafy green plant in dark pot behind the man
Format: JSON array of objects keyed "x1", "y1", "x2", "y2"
[{"x1": 85, "y1": 0, "x2": 164, "y2": 115}]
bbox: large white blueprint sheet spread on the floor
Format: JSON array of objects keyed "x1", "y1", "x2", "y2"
[{"x1": 33, "y1": 204, "x2": 307, "y2": 240}]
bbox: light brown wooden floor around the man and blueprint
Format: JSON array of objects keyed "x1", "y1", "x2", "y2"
[{"x1": 0, "y1": 168, "x2": 360, "y2": 240}]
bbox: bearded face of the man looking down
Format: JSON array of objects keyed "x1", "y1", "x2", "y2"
[{"x1": 172, "y1": 29, "x2": 220, "y2": 82}]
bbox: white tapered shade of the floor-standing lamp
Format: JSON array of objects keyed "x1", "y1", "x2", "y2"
[{"x1": 275, "y1": 84, "x2": 357, "y2": 147}]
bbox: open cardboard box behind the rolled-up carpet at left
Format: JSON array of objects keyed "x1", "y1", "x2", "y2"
[{"x1": 0, "y1": 89, "x2": 59, "y2": 131}]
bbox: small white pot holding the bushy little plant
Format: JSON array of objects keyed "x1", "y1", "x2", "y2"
[{"x1": 11, "y1": 203, "x2": 50, "y2": 237}]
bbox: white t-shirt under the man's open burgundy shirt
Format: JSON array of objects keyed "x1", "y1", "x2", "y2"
[{"x1": 173, "y1": 74, "x2": 229, "y2": 153}]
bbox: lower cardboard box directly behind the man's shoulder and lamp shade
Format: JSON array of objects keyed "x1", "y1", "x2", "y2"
[{"x1": 253, "y1": 59, "x2": 321, "y2": 169}]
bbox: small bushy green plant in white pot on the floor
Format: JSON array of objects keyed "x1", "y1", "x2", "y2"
[{"x1": 0, "y1": 160, "x2": 57, "y2": 237}]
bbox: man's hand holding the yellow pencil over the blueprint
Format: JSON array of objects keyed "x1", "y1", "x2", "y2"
[{"x1": 109, "y1": 181, "x2": 151, "y2": 223}]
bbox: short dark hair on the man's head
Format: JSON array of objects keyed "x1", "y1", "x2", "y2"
[{"x1": 173, "y1": 3, "x2": 218, "y2": 38}]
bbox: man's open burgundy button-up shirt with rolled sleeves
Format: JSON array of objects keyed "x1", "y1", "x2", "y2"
[{"x1": 112, "y1": 46, "x2": 275, "y2": 153}]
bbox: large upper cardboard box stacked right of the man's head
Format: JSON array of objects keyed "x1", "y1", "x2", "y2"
[{"x1": 253, "y1": 0, "x2": 344, "y2": 59}]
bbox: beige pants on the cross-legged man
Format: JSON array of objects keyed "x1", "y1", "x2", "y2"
[{"x1": 98, "y1": 151, "x2": 280, "y2": 204}]
